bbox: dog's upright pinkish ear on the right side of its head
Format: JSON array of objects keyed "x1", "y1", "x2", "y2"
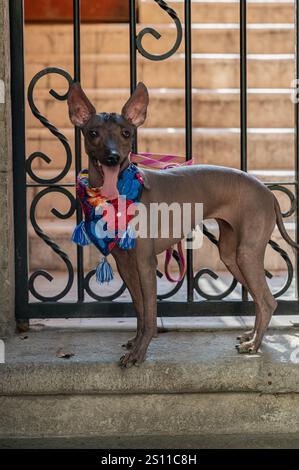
[{"x1": 121, "y1": 82, "x2": 149, "y2": 127}]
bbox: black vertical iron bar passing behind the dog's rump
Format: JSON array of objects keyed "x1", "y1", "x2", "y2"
[{"x1": 240, "y1": 0, "x2": 248, "y2": 300}]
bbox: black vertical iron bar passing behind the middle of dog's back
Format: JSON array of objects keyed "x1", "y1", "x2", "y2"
[{"x1": 184, "y1": 0, "x2": 194, "y2": 302}]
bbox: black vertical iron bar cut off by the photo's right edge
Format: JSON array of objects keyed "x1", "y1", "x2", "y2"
[{"x1": 295, "y1": 0, "x2": 299, "y2": 300}]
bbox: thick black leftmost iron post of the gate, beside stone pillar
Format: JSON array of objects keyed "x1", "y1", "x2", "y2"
[{"x1": 9, "y1": 0, "x2": 29, "y2": 319}]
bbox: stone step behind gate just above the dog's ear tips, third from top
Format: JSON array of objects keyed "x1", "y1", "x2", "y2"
[{"x1": 26, "y1": 54, "x2": 294, "y2": 90}]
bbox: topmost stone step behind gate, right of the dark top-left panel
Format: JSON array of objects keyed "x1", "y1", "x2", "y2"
[{"x1": 139, "y1": 0, "x2": 294, "y2": 23}]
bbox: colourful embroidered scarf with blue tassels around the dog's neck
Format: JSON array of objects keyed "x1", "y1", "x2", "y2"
[{"x1": 72, "y1": 163, "x2": 143, "y2": 284}]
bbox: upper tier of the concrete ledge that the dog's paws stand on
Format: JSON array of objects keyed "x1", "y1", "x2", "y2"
[{"x1": 0, "y1": 328, "x2": 299, "y2": 396}]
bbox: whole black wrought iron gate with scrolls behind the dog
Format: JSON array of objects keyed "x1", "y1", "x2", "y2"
[{"x1": 10, "y1": 0, "x2": 299, "y2": 319}]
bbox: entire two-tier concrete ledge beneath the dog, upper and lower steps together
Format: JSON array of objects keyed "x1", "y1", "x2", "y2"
[{"x1": 0, "y1": 327, "x2": 299, "y2": 447}]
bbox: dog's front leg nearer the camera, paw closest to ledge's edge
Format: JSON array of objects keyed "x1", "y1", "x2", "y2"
[{"x1": 120, "y1": 246, "x2": 157, "y2": 367}]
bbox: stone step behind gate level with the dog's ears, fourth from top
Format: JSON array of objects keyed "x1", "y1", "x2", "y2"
[{"x1": 27, "y1": 88, "x2": 294, "y2": 128}]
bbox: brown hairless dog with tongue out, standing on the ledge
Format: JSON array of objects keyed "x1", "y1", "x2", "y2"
[{"x1": 68, "y1": 83, "x2": 299, "y2": 367}]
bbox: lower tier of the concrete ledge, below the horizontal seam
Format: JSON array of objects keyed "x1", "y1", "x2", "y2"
[{"x1": 0, "y1": 393, "x2": 299, "y2": 438}]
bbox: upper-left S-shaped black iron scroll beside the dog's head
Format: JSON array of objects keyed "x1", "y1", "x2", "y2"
[{"x1": 26, "y1": 67, "x2": 73, "y2": 184}]
